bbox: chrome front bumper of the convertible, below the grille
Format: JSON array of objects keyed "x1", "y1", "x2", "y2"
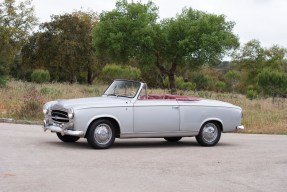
[{"x1": 43, "y1": 120, "x2": 84, "y2": 137}]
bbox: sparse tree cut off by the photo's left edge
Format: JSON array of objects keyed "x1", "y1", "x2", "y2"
[{"x1": 0, "y1": 0, "x2": 37, "y2": 80}]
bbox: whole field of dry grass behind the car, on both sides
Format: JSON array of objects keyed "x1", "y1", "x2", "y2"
[{"x1": 0, "y1": 81, "x2": 287, "y2": 134}]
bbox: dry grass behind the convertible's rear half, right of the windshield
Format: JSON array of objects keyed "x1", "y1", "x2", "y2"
[{"x1": 151, "y1": 89, "x2": 287, "y2": 134}]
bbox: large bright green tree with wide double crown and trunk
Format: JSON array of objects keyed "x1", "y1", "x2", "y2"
[{"x1": 94, "y1": 0, "x2": 238, "y2": 93}]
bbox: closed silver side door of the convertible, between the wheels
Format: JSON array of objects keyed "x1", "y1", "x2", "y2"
[{"x1": 134, "y1": 100, "x2": 179, "y2": 133}]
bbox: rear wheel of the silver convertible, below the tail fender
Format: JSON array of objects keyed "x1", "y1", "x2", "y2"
[{"x1": 195, "y1": 122, "x2": 221, "y2": 147}]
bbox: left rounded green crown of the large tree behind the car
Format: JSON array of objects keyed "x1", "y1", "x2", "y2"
[{"x1": 93, "y1": 0, "x2": 158, "y2": 63}]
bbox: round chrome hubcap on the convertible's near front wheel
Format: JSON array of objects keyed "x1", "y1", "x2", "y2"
[{"x1": 94, "y1": 124, "x2": 112, "y2": 145}]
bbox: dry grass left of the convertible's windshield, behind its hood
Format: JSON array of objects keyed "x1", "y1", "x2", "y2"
[{"x1": 0, "y1": 81, "x2": 106, "y2": 120}]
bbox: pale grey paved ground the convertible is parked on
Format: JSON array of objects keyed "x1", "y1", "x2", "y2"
[{"x1": 0, "y1": 123, "x2": 287, "y2": 192}]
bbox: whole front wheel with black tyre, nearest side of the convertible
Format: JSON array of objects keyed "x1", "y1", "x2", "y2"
[{"x1": 87, "y1": 119, "x2": 115, "y2": 149}]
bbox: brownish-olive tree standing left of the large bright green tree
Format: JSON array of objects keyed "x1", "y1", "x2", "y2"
[{"x1": 22, "y1": 11, "x2": 97, "y2": 83}]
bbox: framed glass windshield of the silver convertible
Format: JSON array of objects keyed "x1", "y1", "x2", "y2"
[{"x1": 104, "y1": 80, "x2": 141, "y2": 98}]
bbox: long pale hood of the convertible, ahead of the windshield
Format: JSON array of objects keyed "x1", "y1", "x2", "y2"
[{"x1": 46, "y1": 96, "x2": 131, "y2": 109}]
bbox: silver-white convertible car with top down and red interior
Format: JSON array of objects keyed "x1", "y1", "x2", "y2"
[{"x1": 43, "y1": 80, "x2": 244, "y2": 149}]
